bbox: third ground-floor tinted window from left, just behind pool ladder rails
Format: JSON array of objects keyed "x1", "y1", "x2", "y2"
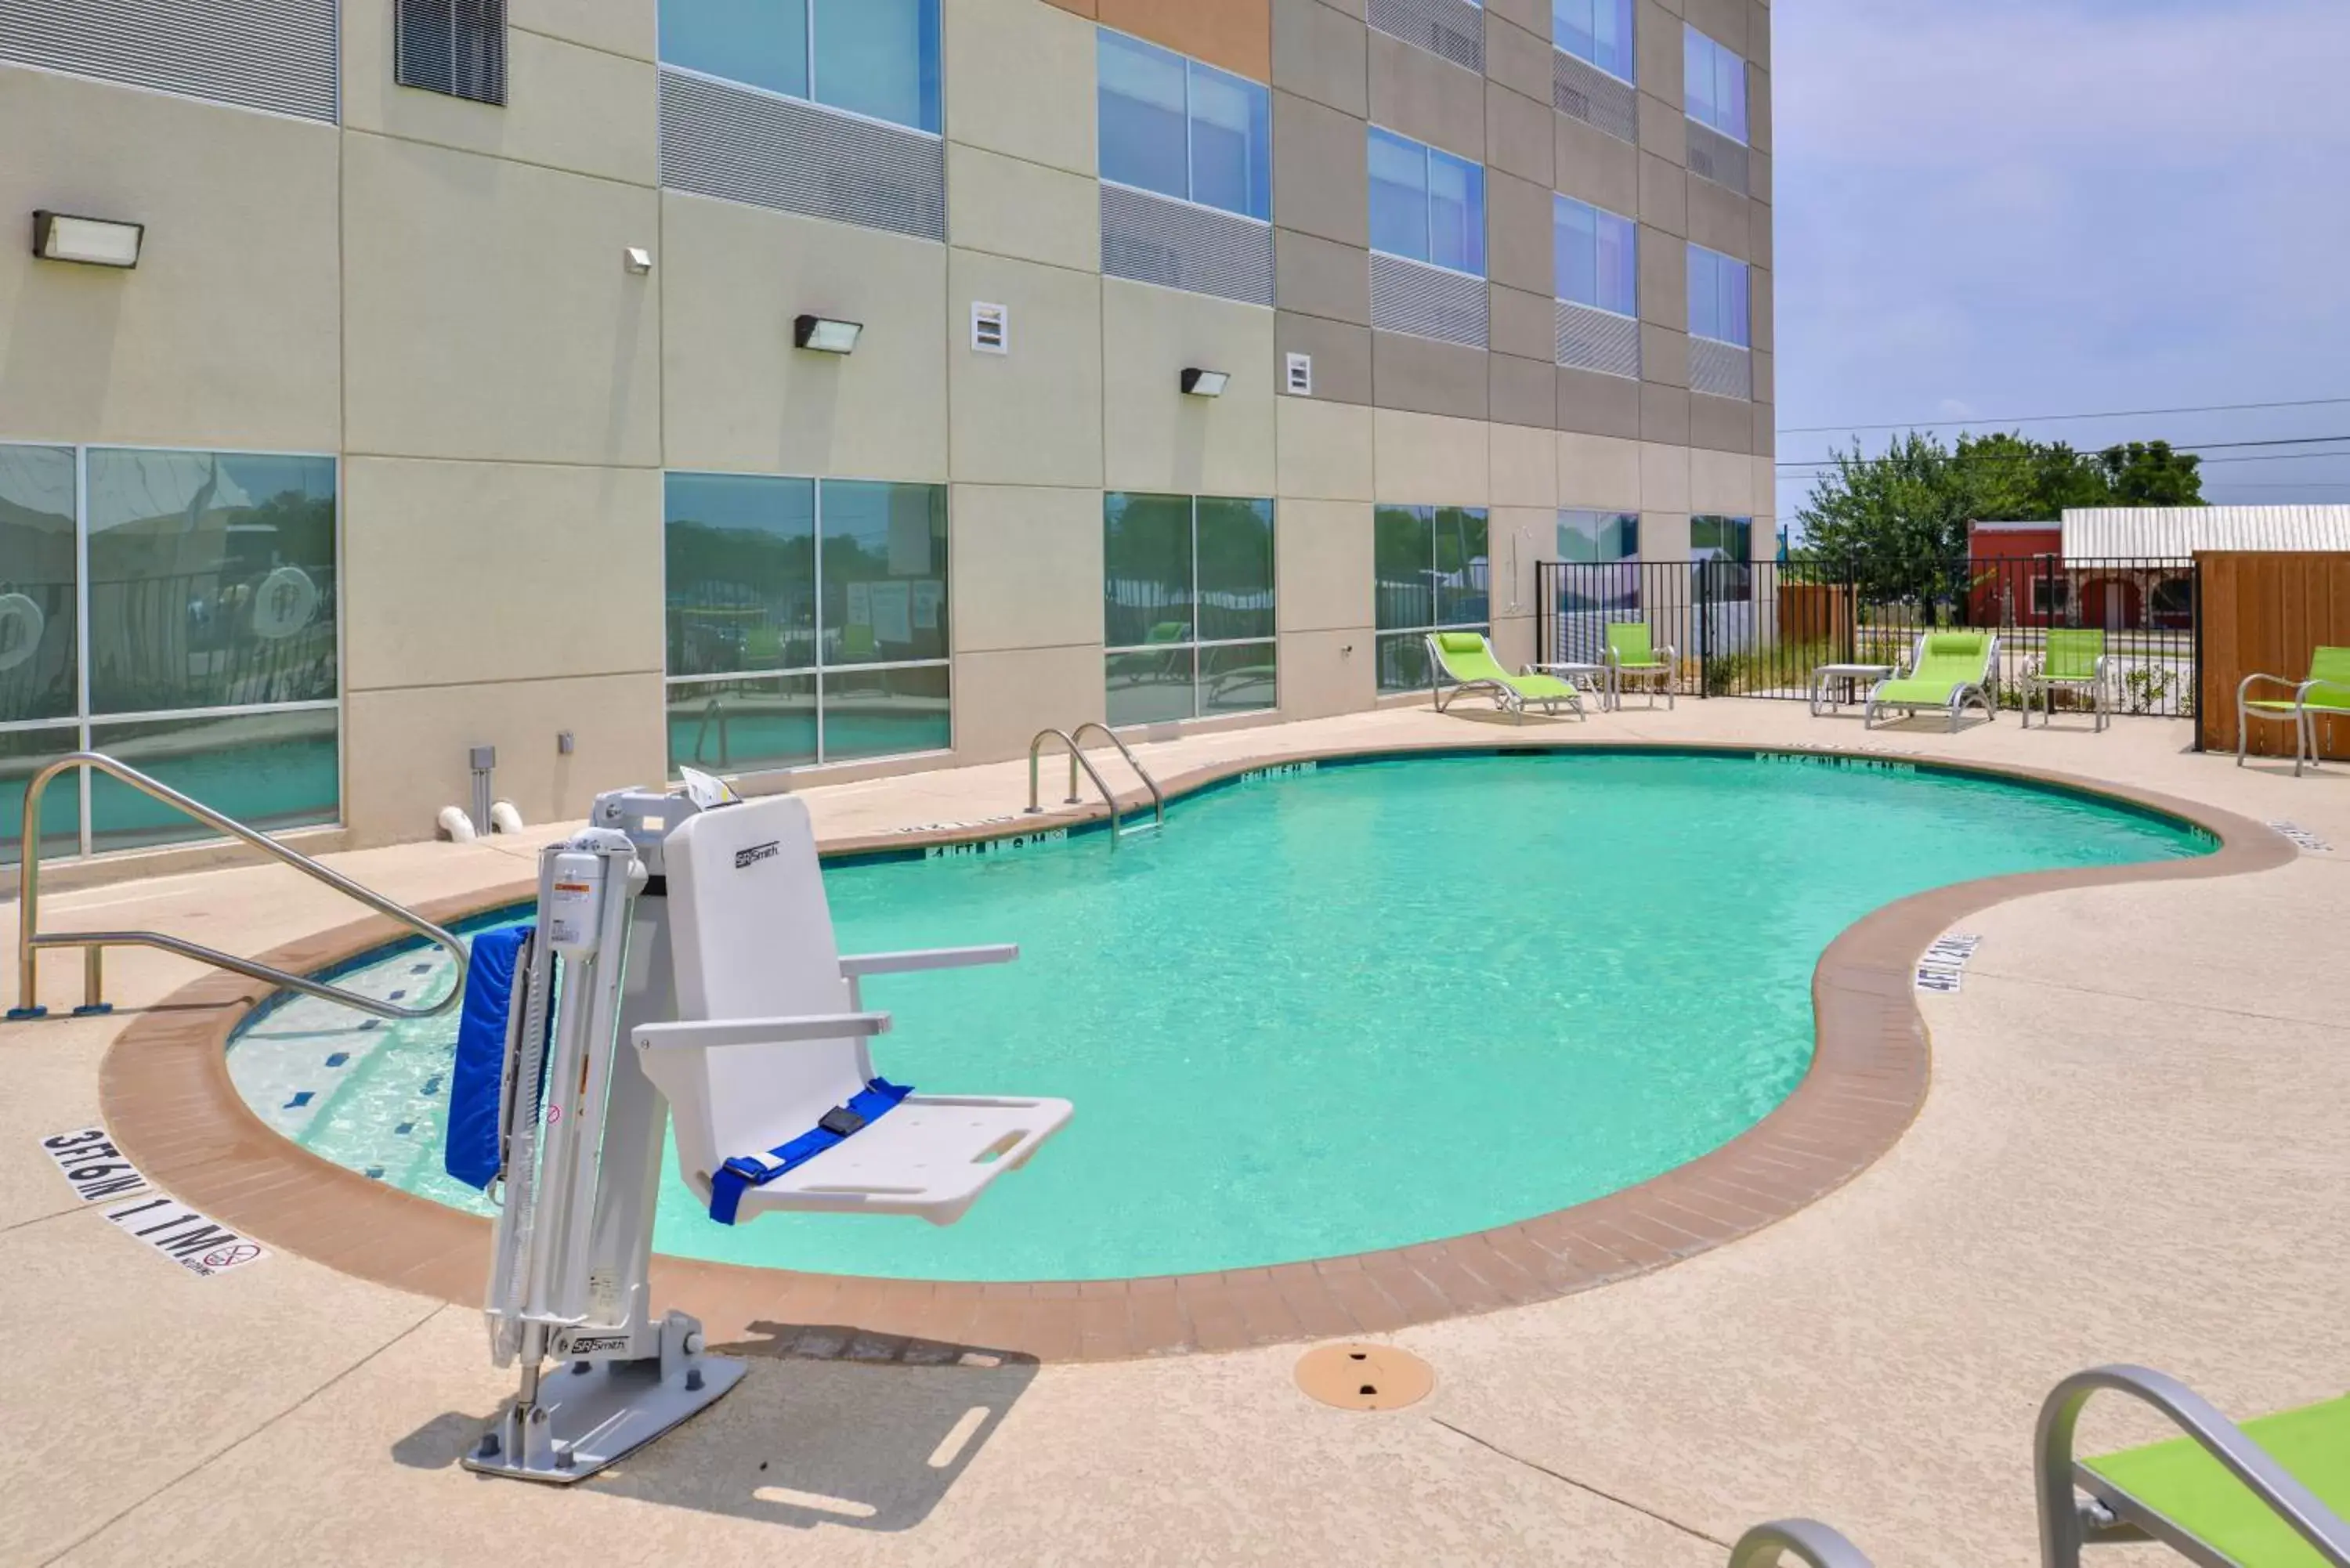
[{"x1": 1102, "y1": 493, "x2": 1281, "y2": 724}]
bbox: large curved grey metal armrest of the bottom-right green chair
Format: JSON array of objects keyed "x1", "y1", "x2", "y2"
[{"x1": 2033, "y1": 1366, "x2": 2350, "y2": 1568}]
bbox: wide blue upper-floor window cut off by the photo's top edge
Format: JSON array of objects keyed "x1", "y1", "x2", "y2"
[{"x1": 660, "y1": 0, "x2": 940, "y2": 134}]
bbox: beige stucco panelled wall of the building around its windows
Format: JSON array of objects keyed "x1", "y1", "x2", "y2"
[{"x1": 0, "y1": 0, "x2": 1772, "y2": 860}]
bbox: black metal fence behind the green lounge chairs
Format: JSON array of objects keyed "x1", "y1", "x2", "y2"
[{"x1": 1535, "y1": 557, "x2": 2200, "y2": 717}]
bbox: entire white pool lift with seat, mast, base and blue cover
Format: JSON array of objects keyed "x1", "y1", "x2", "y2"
[{"x1": 449, "y1": 773, "x2": 1072, "y2": 1483}]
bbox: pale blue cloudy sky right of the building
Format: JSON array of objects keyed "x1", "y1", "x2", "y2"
[{"x1": 1772, "y1": 0, "x2": 2350, "y2": 519}]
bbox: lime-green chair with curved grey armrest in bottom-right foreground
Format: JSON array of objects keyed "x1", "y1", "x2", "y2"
[{"x1": 2035, "y1": 1366, "x2": 2350, "y2": 1568}]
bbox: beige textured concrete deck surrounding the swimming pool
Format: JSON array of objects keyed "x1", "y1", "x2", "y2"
[{"x1": 0, "y1": 700, "x2": 2350, "y2": 1568}]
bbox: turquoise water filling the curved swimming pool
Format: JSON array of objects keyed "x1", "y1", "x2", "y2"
[{"x1": 230, "y1": 754, "x2": 2209, "y2": 1279}]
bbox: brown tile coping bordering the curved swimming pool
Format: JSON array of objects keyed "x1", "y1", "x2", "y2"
[{"x1": 99, "y1": 740, "x2": 2296, "y2": 1361}]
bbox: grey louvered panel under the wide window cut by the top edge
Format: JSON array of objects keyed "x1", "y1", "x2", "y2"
[{"x1": 660, "y1": 68, "x2": 947, "y2": 240}]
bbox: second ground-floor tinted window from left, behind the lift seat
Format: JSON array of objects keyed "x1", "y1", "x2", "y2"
[{"x1": 665, "y1": 472, "x2": 952, "y2": 773}]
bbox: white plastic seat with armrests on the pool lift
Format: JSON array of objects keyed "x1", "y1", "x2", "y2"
[{"x1": 632, "y1": 795, "x2": 1072, "y2": 1225}]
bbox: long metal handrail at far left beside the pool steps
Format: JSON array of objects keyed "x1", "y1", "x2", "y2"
[{"x1": 7, "y1": 752, "x2": 465, "y2": 1023}]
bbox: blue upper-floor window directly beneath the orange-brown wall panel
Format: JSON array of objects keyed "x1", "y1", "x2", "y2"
[{"x1": 1100, "y1": 28, "x2": 1274, "y2": 219}]
